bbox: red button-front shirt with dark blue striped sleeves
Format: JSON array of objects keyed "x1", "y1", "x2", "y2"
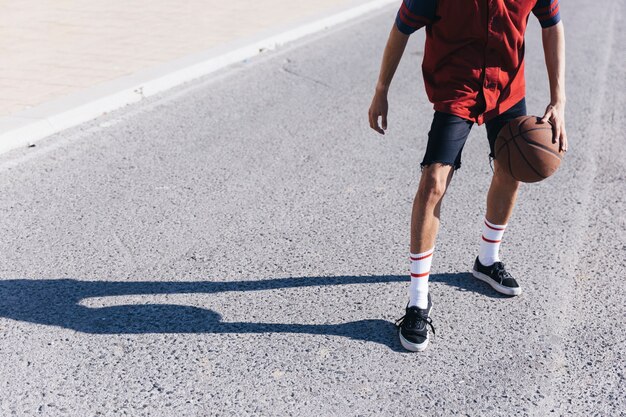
[{"x1": 396, "y1": 0, "x2": 560, "y2": 124}]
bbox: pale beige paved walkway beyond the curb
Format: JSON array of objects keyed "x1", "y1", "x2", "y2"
[{"x1": 0, "y1": 0, "x2": 354, "y2": 117}]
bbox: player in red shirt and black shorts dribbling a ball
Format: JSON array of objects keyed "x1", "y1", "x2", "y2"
[{"x1": 369, "y1": 0, "x2": 567, "y2": 351}]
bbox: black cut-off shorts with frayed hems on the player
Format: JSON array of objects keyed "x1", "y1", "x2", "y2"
[{"x1": 422, "y1": 99, "x2": 526, "y2": 169}]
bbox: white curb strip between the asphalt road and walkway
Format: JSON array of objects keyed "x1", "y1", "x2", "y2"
[{"x1": 0, "y1": 0, "x2": 399, "y2": 153}]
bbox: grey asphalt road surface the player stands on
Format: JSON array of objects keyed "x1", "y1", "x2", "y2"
[{"x1": 0, "y1": 0, "x2": 626, "y2": 416}]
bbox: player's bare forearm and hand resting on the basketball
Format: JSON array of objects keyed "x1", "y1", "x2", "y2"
[{"x1": 541, "y1": 22, "x2": 567, "y2": 152}]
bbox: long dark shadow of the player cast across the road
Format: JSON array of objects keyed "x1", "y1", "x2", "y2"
[{"x1": 0, "y1": 274, "x2": 492, "y2": 351}]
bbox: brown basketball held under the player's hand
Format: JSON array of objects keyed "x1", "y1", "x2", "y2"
[{"x1": 494, "y1": 116, "x2": 563, "y2": 182}]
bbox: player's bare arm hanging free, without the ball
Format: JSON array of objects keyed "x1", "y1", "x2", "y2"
[{"x1": 368, "y1": 24, "x2": 409, "y2": 135}]
